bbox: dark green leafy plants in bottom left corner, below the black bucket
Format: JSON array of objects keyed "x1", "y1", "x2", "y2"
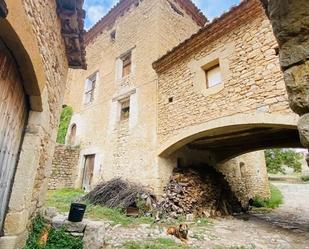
[{"x1": 24, "y1": 217, "x2": 83, "y2": 249}]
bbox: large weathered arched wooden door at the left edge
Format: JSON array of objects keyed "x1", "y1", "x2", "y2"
[{"x1": 0, "y1": 39, "x2": 28, "y2": 233}]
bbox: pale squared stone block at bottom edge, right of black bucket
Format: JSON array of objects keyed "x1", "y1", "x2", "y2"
[{"x1": 83, "y1": 221, "x2": 108, "y2": 249}]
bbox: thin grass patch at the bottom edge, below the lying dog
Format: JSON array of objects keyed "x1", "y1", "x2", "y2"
[{"x1": 121, "y1": 238, "x2": 192, "y2": 249}]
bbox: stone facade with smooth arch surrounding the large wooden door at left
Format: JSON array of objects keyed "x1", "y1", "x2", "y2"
[{"x1": 0, "y1": 0, "x2": 82, "y2": 249}]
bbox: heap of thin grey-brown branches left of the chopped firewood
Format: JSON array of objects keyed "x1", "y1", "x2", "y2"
[{"x1": 83, "y1": 178, "x2": 156, "y2": 209}]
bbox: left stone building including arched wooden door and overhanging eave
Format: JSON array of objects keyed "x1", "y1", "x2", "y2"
[{"x1": 0, "y1": 0, "x2": 86, "y2": 249}]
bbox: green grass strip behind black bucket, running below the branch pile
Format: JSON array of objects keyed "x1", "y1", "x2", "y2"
[{"x1": 45, "y1": 189, "x2": 154, "y2": 226}]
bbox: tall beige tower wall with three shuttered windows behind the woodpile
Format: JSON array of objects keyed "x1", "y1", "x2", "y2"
[{"x1": 65, "y1": 0, "x2": 198, "y2": 191}]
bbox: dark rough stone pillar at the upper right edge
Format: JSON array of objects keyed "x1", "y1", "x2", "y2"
[{"x1": 261, "y1": 0, "x2": 309, "y2": 148}]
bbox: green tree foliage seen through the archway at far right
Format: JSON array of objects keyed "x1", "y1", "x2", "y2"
[{"x1": 265, "y1": 149, "x2": 303, "y2": 174}]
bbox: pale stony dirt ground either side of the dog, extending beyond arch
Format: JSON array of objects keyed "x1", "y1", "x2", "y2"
[{"x1": 107, "y1": 183, "x2": 309, "y2": 249}]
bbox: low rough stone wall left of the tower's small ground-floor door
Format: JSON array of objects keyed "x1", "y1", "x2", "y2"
[{"x1": 48, "y1": 144, "x2": 80, "y2": 190}]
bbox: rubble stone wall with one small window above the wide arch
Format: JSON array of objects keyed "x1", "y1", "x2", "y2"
[{"x1": 158, "y1": 6, "x2": 293, "y2": 143}]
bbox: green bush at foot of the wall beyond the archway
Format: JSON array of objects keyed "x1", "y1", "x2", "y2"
[{"x1": 253, "y1": 185, "x2": 283, "y2": 209}]
